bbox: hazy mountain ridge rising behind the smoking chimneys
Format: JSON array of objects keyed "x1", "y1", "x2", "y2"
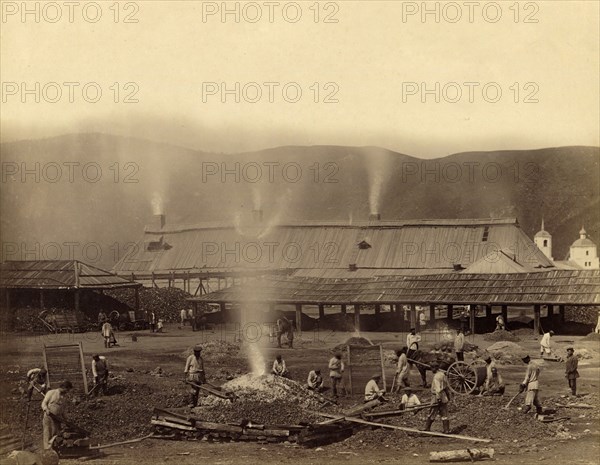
[{"x1": 0, "y1": 134, "x2": 600, "y2": 266}]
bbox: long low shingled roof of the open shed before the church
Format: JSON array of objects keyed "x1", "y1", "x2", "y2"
[{"x1": 189, "y1": 270, "x2": 600, "y2": 305}]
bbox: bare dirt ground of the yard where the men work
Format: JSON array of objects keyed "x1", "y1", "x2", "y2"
[{"x1": 0, "y1": 325, "x2": 600, "y2": 465}]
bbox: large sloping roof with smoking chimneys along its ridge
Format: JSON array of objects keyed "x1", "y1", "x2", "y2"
[{"x1": 113, "y1": 218, "x2": 554, "y2": 277}]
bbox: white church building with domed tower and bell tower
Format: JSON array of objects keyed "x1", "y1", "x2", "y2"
[{"x1": 533, "y1": 219, "x2": 600, "y2": 270}]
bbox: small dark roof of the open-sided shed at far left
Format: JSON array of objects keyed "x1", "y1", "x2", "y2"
[{"x1": 0, "y1": 260, "x2": 141, "y2": 289}]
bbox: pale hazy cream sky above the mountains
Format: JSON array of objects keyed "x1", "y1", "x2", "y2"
[{"x1": 0, "y1": 1, "x2": 600, "y2": 157}]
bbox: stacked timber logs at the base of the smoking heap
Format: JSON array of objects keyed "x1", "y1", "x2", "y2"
[{"x1": 151, "y1": 408, "x2": 352, "y2": 447}]
